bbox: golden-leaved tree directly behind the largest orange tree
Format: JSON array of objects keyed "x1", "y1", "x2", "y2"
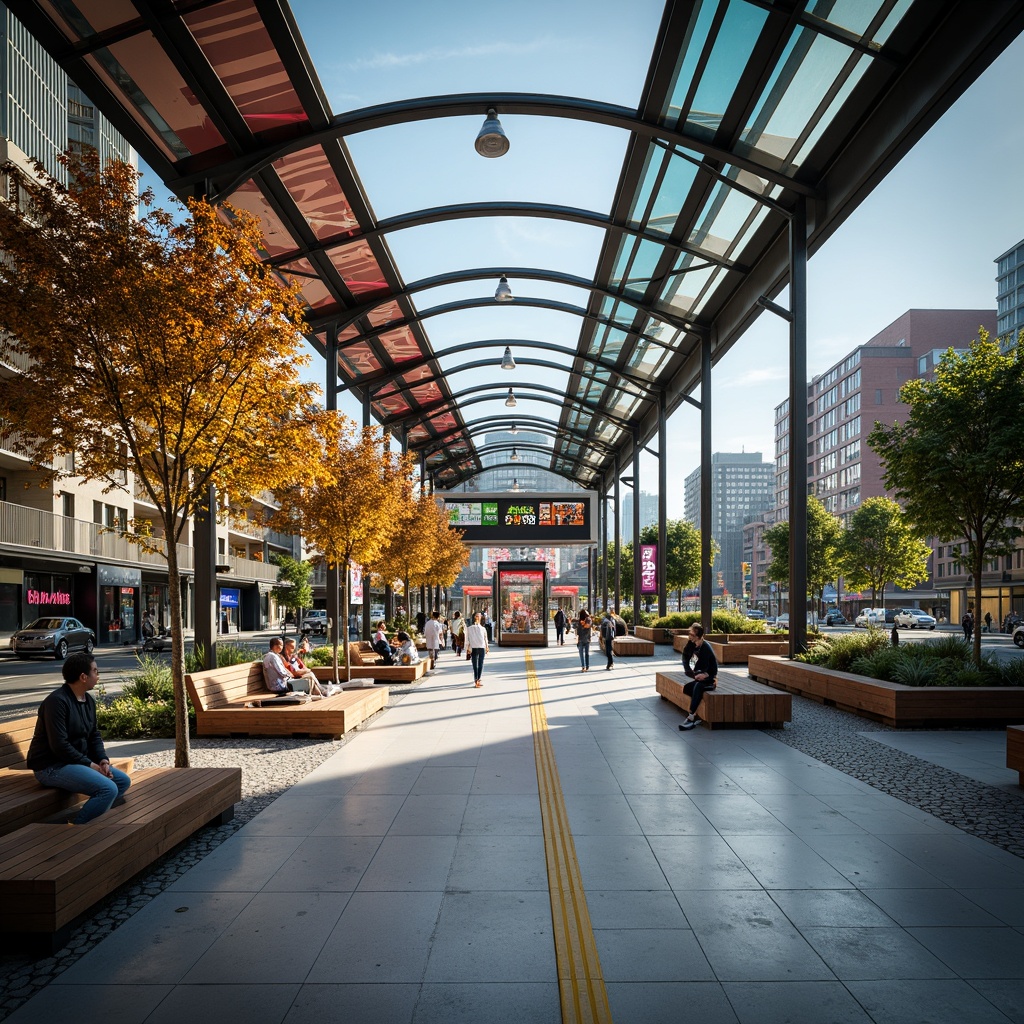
[{"x1": 269, "y1": 412, "x2": 413, "y2": 682}]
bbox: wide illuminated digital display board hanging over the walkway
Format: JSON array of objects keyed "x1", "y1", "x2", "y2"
[{"x1": 438, "y1": 490, "x2": 597, "y2": 546}]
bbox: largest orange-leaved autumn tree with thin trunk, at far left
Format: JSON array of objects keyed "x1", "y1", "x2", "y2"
[{"x1": 0, "y1": 155, "x2": 313, "y2": 767}]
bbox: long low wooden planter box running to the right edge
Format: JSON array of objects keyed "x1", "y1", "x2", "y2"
[{"x1": 748, "y1": 655, "x2": 1024, "y2": 728}]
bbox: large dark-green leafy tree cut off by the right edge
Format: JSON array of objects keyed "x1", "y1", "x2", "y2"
[{"x1": 867, "y1": 330, "x2": 1024, "y2": 665}]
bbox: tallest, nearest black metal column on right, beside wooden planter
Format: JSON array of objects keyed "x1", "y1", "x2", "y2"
[{"x1": 790, "y1": 196, "x2": 807, "y2": 657}]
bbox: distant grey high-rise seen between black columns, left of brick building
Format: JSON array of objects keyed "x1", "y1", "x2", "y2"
[{"x1": 684, "y1": 452, "x2": 775, "y2": 597}]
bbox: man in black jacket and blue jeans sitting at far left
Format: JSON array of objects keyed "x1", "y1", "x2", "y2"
[{"x1": 26, "y1": 651, "x2": 131, "y2": 825}]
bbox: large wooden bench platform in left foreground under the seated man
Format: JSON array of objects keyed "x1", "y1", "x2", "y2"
[{"x1": 0, "y1": 768, "x2": 242, "y2": 950}]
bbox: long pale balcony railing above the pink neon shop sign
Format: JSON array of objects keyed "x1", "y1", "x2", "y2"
[{"x1": 0, "y1": 502, "x2": 192, "y2": 574}]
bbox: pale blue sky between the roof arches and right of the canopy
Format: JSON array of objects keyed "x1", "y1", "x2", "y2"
[{"x1": 276, "y1": 6, "x2": 1024, "y2": 516}]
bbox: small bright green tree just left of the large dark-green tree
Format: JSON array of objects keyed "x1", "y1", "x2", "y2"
[{"x1": 839, "y1": 498, "x2": 932, "y2": 604}]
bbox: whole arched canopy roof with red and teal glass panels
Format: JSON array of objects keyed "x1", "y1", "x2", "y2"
[{"x1": 14, "y1": 0, "x2": 1024, "y2": 489}]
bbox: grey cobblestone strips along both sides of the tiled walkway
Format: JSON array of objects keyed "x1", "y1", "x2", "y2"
[{"x1": 0, "y1": 688, "x2": 1024, "y2": 1021}]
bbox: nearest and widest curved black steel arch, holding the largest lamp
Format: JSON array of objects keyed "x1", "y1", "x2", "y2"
[{"x1": 188, "y1": 92, "x2": 818, "y2": 203}]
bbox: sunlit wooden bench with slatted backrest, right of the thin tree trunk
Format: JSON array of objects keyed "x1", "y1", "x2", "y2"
[{"x1": 185, "y1": 662, "x2": 389, "y2": 739}]
